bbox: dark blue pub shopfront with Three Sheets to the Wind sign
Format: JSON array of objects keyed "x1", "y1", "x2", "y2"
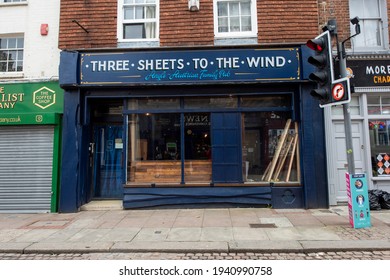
[{"x1": 59, "y1": 46, "x2": 328, "y2": 212}]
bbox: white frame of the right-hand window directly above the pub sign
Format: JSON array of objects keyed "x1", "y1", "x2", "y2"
[{"x1": 213, "y1": 0, "x2": 257, "y2": 38}]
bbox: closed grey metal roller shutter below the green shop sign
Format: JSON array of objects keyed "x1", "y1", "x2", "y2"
[{"x1": 0, "y1": 126, "x2": 54, "y2": 213}]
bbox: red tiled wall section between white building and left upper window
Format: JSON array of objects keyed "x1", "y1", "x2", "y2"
[{"x1": 59, "y1": 0, "x2": 117, "y2": 49}]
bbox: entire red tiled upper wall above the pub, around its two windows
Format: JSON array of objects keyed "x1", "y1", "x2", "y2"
[{"x1": 59, "y1": 0, "x2": 390, "y2": 49}]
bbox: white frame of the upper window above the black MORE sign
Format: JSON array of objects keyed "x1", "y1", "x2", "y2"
[{"x1": 349, "y1": 0, "x2": 389, "y2": 52}]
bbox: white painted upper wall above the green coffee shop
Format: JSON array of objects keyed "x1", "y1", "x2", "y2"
[{"x1": 0, "y1": 0, "x2": 60, "y2": 82}]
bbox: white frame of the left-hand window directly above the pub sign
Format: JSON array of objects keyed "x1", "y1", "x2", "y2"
[{"x1": 117, "y1": 0, "x2": 160, "y2": 42}]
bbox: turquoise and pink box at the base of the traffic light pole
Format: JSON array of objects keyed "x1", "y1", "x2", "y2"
[{"x1": 345, "y1": 173, "x2": 371, "y2": 228}]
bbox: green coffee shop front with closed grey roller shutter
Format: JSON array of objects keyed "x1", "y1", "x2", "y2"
[{"x1": 0, "y1": 81, "x2": 63, "y2": 213}]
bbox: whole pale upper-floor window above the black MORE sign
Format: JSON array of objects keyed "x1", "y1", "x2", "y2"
[{"x1": 349, "y1": 0, "x2": 388, "y2": 51}]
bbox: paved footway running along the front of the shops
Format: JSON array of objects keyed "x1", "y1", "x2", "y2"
[{"x1": 0, "y1": 202, "x2": 390, "y2": 254}]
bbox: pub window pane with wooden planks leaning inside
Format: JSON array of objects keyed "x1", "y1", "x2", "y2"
[{"x1": 242, "y1": 112, "x2": 300, "y2": 182}]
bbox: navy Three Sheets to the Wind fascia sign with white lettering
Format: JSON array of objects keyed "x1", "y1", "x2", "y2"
[{"x1": 80, "y1": 48, "x2": 300, "y2": 85}]
